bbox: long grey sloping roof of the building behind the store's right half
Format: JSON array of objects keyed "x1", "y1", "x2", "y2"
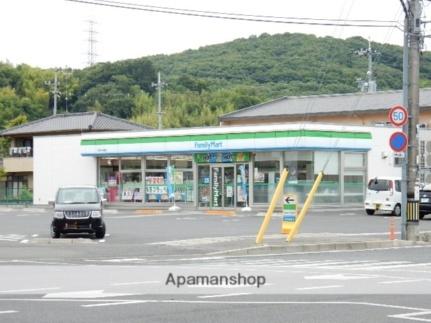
[{"x1": 220, "y1": 88, "x2": 431, "y2": 121}]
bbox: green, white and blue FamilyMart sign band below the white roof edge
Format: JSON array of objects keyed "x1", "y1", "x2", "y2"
[{"x1": 81, "y1": 130, "x2": 372, "y2": 156}]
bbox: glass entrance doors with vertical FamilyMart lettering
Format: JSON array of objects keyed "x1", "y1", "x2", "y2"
[{"x1": 211, "y1": 165, "x2": 235, "y2": 208}]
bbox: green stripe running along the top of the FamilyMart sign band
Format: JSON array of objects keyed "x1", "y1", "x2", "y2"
[{"x1": 81, "y1": 130, "x2": 372, "y2": 146}]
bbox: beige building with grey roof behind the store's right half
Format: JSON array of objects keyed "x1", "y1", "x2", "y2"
[{"x1": 220, "y1": 88, "x2": 431, "y2": 128}]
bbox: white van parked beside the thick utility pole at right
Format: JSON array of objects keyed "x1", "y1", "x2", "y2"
[{"x1": 364, "y1": 177, "x2": 401, "y2": 216}]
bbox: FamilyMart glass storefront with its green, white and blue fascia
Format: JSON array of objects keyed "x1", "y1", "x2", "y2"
[{"x1": 80, "y1": 124, "x2": 385, "y2": 208}]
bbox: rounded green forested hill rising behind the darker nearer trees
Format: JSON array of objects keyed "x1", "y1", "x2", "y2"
[{"x1": 150, "y1": 33, "x2": 431, "y2": 97}]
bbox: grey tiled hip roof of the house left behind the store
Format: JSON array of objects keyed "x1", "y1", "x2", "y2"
[{"x1": 0, "y1": 112, "x2": 150, "y2": 136}]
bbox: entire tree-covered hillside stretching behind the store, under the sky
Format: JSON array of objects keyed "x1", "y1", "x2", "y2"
[{"x1": 0, "y1": 33, "x2": 431, "y2": 128}]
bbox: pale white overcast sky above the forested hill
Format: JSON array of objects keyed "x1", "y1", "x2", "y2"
[{"x1": 0, "y1": 0, "x2": 431, "y2": 68}]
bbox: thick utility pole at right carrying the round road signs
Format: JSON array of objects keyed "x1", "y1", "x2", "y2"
[{"x1": 401, "y1": 0, "x2": 422, "y2": 240}]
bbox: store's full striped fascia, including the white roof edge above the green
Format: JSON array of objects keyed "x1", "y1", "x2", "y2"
[{"x1": 81, "y1": 124, "x2": 372, "y2": 157}]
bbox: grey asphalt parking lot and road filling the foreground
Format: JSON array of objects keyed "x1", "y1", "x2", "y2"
[{"x1": 0, "y1": 207, "x2": 431, "y2": 322}]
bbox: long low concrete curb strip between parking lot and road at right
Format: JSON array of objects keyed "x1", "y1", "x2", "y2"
[{"x1": 207, "y1": 240, "x2": 431, "y2": 256}]
